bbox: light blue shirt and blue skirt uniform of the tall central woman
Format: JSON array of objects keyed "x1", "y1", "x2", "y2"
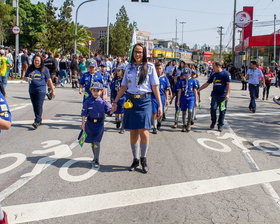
[{"x1": 122, "y1": 63, "x2": 159, "y2": 130}]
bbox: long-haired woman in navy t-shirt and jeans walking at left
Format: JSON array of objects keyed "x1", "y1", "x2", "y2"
[{"x1": 24, "y1": 55, "x2": 55, "y2": 129}]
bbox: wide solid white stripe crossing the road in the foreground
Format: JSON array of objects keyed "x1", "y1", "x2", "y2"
[{"x1": 3, "y1": 169, "x2": 280, "y2": 223}]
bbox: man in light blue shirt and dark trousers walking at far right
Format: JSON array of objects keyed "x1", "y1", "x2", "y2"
[{"x1": 246, "y1": 61, "x2": 265, "y2": 113}]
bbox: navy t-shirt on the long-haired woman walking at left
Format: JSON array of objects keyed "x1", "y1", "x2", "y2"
[{"x1": 24, "y1": 66, "x2": 51, "y2": 93}]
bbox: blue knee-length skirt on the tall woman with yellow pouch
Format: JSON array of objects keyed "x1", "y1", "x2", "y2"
[{"x1": 124, "y1": 96, "x2": 152, "y2": 130}]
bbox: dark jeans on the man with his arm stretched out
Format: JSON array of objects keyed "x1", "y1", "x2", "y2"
[{"x1": 210, "y1": 96, "x2": 227, "y2": 127}]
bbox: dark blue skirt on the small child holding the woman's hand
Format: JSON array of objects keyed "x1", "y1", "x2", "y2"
[{"x1": 85, "y1": 120, "x2": 104, "y2": 143}]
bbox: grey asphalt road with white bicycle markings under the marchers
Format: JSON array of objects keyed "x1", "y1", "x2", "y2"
[{"x1": 0, "y1": 77, "x2": 280, "y2": 224}]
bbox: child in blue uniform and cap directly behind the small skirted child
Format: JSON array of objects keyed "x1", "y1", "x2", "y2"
[{"x1": 79, "y1": 61, "x2": 106, "y2": 102}]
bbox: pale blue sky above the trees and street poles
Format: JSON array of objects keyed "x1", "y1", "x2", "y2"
[{"x1": 31, "y1": 0, "x2": 280, "y2": 47}]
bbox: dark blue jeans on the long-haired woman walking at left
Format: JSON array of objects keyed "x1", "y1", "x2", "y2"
[{"x1": 29, "y1": 92, "x2": 46, "y2": 123}]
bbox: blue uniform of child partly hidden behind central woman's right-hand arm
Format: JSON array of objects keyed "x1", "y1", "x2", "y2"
[{"x1": 152, "y1": 74, "x2": 170, "y2": 114}]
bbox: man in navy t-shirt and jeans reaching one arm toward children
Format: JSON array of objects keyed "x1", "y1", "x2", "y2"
[{"x1": 198, "y1": 62, "x2": 231, "y2": 132}]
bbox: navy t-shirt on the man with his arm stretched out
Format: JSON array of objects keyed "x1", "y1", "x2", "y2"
[{"x1": 207, "y1": 71, "x2": 231, "y2": 97}]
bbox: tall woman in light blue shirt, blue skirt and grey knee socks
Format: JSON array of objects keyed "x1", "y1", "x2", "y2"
[{"x1": 112, "y1": 44, "x2": 162, "y2": 173}]
